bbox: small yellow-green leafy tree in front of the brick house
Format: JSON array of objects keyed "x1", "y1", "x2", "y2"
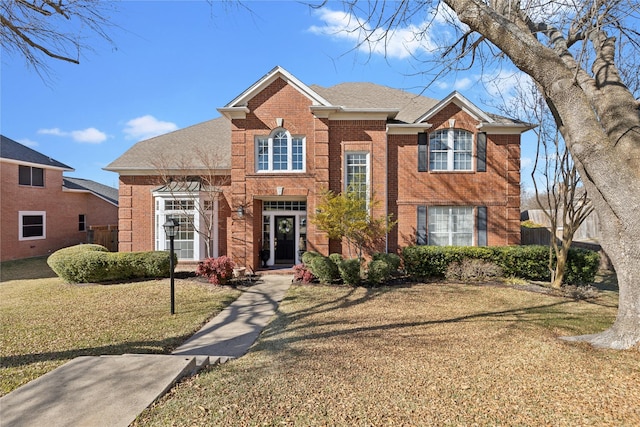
[{"x1": 310, "y1": 185, "x2": 396, "y2": 261}]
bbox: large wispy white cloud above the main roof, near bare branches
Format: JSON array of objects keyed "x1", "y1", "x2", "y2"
[{"x1": 309, "y1": 8, "x2": 436, "y2": 59}]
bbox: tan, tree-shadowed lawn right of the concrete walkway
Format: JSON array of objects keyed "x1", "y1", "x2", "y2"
[{"x1": 135, "y1": 283, "x2": 640, "y2": 426}]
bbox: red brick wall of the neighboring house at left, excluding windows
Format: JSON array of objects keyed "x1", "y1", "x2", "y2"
[{"x1": 0, "y1": 162, "x2": 118, "y2": 261}]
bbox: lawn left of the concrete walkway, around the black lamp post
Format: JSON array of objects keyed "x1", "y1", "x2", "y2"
[{"x1": 0, "y1": 258, "x2": 239, "y2": 395}]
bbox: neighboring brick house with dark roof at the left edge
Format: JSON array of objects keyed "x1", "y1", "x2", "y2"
[{"x1": 0, "y1": 136, "x2": 118, "y2": 261}]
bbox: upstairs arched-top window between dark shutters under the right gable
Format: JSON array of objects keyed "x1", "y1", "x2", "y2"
[{"x1": 429, "y1": 129, "x2": 473, "y2": 171}]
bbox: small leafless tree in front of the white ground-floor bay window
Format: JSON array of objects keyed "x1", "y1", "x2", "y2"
[{"x1": 153, "y1": 147, "x2": 231, "y2": 257}]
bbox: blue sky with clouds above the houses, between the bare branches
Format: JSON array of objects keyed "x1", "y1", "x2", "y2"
[{"x1": 0, "y1": 1, "x2": 535, "y2": 191}]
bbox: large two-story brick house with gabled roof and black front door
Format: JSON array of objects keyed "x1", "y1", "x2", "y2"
[{"x1": 105, "y1": 67, "x2": 532, "y2": 269}]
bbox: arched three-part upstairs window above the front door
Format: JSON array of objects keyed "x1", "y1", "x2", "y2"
[{"x1": 256, "y1": 129, "x2": 305, "y2": 172}]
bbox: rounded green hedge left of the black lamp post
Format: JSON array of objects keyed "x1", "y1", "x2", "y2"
[{"x1": 47, "y1": 244, "x2": 175, "y2": 283}]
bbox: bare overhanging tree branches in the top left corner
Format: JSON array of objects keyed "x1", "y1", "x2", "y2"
[{"x1": 0, "y1": 0, "x2": 114, "y2": 73}]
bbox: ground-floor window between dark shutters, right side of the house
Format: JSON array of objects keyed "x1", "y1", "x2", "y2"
[{"x1": 428, "y1": 206, "x2": 474, "y2": 246}]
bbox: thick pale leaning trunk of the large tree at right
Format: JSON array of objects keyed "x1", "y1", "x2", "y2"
[{"x1": 444, "y1": 0, "x2": 640, "y2": 349}]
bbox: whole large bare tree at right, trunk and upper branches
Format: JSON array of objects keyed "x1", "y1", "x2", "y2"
[{"x1": 330, "y1": 0, "x2": 640, "y2": 349}]
